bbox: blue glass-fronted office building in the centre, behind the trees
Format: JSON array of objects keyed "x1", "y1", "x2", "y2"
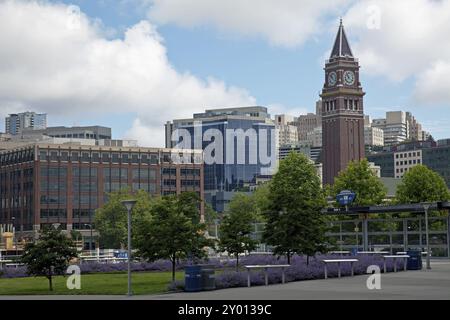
[{"x1": 166, "y1": 107, "x2": 278, "y2": 212}]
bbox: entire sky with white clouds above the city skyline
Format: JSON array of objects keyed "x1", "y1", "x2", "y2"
[{"x1": 0, "y1": 0, "x2": 450, "y2": 147}]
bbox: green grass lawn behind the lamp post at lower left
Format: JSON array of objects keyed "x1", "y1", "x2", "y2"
[{"x1": 0, "y1": 272, "x2": 184, "y2": 295}]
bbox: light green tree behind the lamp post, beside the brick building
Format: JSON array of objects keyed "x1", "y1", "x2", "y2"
[{"x1": 94, "y1": 190, "x2": 153, "y2": 248}]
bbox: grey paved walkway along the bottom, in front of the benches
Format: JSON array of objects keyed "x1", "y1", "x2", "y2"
[{"x1": 0, "y1": 261, "x2": 450, "y2": 300}]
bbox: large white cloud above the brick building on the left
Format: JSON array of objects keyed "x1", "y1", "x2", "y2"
[{"x1": 0, "y1": 1, "x2": 255, "y2": 146}]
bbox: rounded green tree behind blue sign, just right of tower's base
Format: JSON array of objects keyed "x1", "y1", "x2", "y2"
[{"x1": 332, "y1": 159, "x2": 387, "y2": 206}]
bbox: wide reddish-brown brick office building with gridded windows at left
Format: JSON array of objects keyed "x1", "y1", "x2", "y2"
[{"x1": 0, "y1": 143, "x2": 204, "y2": 242}]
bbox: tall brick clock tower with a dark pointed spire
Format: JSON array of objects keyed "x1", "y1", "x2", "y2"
[{"x1": 320, "y1": 20, "x2": 365, "y2": 184}]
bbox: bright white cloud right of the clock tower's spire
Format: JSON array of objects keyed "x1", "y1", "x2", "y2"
[{"x1": 344, "y1": 0, "x2": 450, "y2": 104}]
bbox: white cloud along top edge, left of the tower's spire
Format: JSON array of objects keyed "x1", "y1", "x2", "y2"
[{"x1": 148, "y1": 0, "x2": 351, "y2": 47}]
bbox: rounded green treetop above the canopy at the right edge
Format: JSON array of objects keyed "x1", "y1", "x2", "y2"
[{"x1": 396, "y1": 165, "x2": 450, "y2": 203}]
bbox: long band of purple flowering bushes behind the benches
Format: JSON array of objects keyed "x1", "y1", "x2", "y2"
[{"x1": 0, "y1": 255, "x2": 403, "y2": 290}]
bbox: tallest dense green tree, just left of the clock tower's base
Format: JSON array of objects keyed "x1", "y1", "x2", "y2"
[{"x1": 263, "y1": 152, "x2": 327, "y2": 263}]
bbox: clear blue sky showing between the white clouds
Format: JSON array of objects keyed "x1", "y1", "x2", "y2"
[{"x1": 0, "y1": 0, "x2": 450, "y2": 143}]
